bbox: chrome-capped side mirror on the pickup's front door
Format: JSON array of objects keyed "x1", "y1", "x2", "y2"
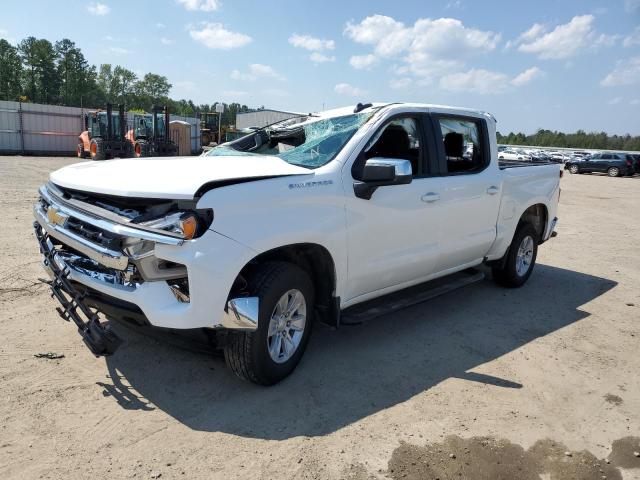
[{"x1": 353, "y1": 157, "x2": 413, "y2": 200}]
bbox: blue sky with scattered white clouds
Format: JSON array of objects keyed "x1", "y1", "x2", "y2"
[{"x1": 0, "y1": 0, "x2": 640, "y2": 134}]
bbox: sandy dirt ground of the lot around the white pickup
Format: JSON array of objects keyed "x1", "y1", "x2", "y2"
[{"x1": 0, "y1": 157, "x2": 640, "y2": 480}]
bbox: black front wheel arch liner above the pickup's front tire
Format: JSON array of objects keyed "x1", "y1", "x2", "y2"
[{"x1": 229, "y1": 243, "x2": 340, "y2": 326}]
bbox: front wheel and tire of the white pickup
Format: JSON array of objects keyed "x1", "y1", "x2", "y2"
[{"x1": 224, "y1": 262, "x2": 315, "y2": 385}]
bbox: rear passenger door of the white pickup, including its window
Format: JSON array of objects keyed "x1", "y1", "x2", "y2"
[{"x1": 426, "y1": 113, "x2": 502, "y2": 272}]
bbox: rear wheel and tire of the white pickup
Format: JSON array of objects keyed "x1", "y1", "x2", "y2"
[{"x1": 491, "y1": 223, "x2": 539, "y2": 288}]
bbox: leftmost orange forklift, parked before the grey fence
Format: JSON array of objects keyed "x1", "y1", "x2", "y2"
[{"x1": 77, "y1": 103, "x2": 133, "y2": 160}]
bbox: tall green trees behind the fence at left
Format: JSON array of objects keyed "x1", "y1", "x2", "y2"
[{"x1": 0, "y1": 37, "x2": 251, "y2": 125}]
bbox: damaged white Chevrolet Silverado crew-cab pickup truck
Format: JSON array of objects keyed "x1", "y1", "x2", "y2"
[{"x1": 34, "y1": 103, "x2": 562, "y2": 385}]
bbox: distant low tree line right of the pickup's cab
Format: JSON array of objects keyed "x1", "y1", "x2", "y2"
[{"x1": 497, "y1": 129, "x2": 640, "y2": 151}]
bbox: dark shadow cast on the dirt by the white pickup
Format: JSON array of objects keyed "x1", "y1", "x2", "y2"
[{"x1": 100, "y1": 264, "x2": 616, "y2": 440}]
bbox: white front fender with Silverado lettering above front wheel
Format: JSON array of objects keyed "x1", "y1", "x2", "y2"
[{"x1": 198, "y1": 169, "x2": 347, "y2": 296}]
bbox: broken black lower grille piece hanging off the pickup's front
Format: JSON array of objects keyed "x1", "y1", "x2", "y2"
[{"x1": 33, "y1": 222, "x2": 122, "y2": 357}]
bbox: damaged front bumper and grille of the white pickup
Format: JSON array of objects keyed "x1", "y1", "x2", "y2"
[{"x1": 34, "y1": 184, "x2": 259, "y2": 355}]
